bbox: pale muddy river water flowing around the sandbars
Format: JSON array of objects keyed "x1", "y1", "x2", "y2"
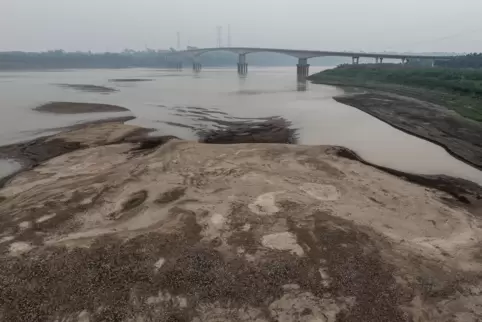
[{"x1": 0, "y1": 68, "x2": 482, "y2": 184}]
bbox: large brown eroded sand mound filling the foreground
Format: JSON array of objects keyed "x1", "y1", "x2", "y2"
[{"x1": 0, "y1": 122, "x2": 482, "y2": 322}]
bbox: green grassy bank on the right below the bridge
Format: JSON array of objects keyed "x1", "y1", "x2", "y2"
[{"x1": 309, "y1": 64, "x2": 482, "y2": 122}]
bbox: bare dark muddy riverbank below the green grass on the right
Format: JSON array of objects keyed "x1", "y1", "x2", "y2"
[{"x1": 310, "y1": 66, "x2": 482, "y2": 169}]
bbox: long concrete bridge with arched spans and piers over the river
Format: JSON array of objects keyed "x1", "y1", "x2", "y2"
[{"x1": 172, "y1": 47, "x2": 453, "y2": 77}]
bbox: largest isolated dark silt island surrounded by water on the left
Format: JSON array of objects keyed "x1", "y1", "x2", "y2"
[{"x1": 34, "y1": 102, "x2": 129, "y2": 114}]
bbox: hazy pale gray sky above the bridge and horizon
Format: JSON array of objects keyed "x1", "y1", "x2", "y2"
[{"x1": 0, "y1": 0, "x2": 482, "y2": 52}]
